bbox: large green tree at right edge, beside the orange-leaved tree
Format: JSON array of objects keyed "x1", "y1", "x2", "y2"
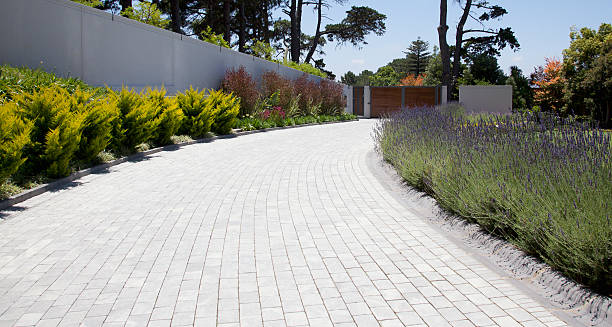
[{"x1": 562, "y1": 24, "x2": 612, "y2": 128}]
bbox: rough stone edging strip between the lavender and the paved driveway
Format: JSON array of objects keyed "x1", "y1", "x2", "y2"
[{"x1": 367, "y1": 151, "x2": 612, "y2": 326}]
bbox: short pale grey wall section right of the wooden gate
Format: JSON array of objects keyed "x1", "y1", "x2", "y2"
[{"x1": 459, "y1": 85, "x2": 512, "y2": 113}]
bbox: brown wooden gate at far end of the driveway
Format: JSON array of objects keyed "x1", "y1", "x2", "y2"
[{"x1": 368, "y1": 86, "x2": 442, "y2": 117}]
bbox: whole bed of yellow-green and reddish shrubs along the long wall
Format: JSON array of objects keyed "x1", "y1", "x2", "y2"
[{"x1": 0, "y1": 66, "x2": 356, "y2": 200}]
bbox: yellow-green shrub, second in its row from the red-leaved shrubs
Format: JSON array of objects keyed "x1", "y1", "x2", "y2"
[{"x1": 176, "y1": 86, "x2": 214, "y2": 138}]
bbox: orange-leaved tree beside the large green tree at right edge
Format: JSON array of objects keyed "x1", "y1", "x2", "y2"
[{"x1": 531, "y1": 58, "x2": 565, "y2": 113}]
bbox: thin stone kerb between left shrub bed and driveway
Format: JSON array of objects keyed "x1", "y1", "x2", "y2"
[{"x1": 0, "y1": 118, "x2": 359, "y2": 211}]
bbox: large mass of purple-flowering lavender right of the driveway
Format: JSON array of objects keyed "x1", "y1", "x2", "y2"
[{"x1": 374, "y1": 108, "x2": 612, "y2": 295}]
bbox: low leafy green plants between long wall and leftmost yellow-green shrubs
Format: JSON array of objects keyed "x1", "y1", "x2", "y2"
[{"x1": 0, "y1": 62, "x2": 106, "y2": 101}]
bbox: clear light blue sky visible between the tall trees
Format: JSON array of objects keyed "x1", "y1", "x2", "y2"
[{"x1": 284, "y1": 0, "x2": 612, "y2": 78}]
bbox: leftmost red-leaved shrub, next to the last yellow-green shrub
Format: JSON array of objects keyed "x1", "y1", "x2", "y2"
[{"x1": 221, "y1": 66, "x2": 259, "y2": 116}]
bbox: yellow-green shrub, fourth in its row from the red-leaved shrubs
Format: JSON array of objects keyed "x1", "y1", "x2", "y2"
[{"x1": 112, "y1": 88, "x2": 159, "y2": 153}]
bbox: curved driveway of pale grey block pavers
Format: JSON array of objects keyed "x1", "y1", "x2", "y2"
[{"x1": 0, "y1": 120, "x2": 564, "y2": 326}]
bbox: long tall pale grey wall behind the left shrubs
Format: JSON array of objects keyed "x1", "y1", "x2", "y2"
[{"x1": 0, "y1": 0, "x2": 330, "y2": 94}]
